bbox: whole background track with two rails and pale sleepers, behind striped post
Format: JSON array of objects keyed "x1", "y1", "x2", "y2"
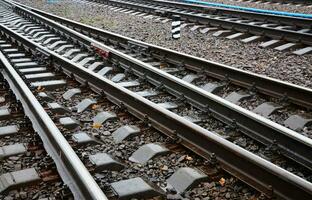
[{"x1": 79, "y1": 0, "x2": 312, "y2": 55}]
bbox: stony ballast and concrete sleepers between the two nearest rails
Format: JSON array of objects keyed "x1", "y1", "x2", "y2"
[{"x1": 1, "y1": 30, "x2": 258, "y2": 199}]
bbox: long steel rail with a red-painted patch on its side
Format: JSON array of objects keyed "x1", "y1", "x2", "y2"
[{"x1": 7, "y1": 0, "x2": 312, "y2": 172}]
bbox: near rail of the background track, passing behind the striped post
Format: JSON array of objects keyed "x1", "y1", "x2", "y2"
[{"x1": 91, "y1": 0, "x2": 312, "y2": 45}]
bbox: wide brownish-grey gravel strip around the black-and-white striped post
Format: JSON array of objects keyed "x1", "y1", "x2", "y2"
[{"x1": 14, "y1": 0, "x2": 312, "y2": 88}]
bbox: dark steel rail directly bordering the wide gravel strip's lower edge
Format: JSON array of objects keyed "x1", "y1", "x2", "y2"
[{"x1": 19, "y1": 0, "x2": 312, "y2": 108}]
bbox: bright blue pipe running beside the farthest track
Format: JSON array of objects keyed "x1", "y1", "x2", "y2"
[{"x1": 181, "y1": 0, "x2": 312, "y2": 19}]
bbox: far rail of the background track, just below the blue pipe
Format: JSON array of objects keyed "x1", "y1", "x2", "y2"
[{"x1": 137, "y1": 0, "x2": 312, "y2": 28}]
